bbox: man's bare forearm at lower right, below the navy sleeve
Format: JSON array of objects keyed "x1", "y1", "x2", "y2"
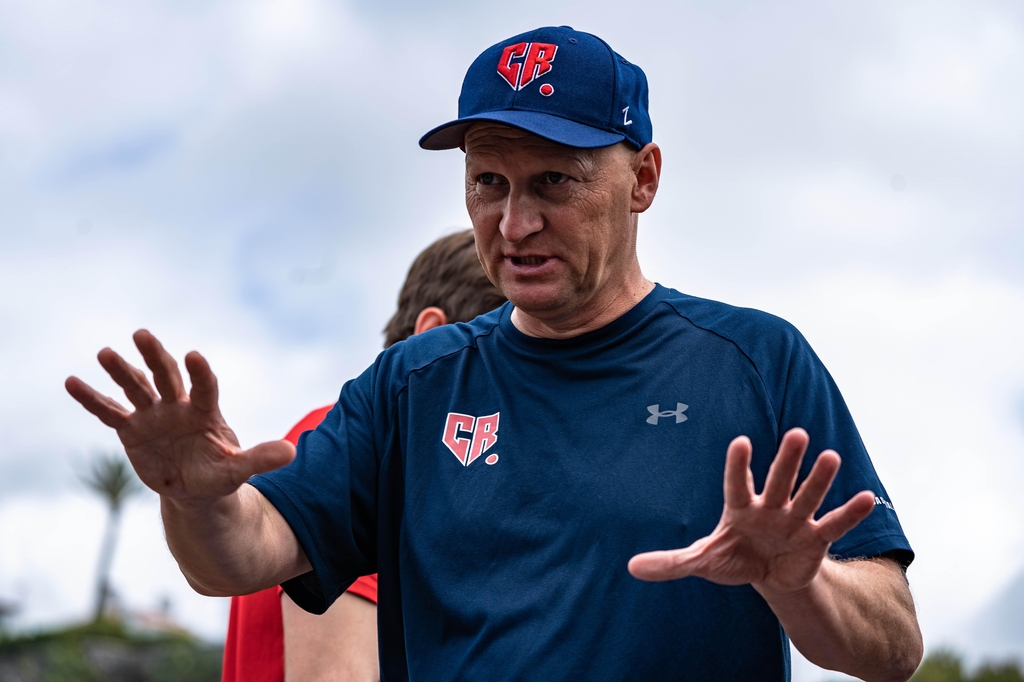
[{"x1": 759, "y1": 559, "x2": 923, "y2": 682}]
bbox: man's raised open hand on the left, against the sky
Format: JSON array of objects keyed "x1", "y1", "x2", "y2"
[{"x1": 65, "y1": 330, "x2": 295, "y2": 505}]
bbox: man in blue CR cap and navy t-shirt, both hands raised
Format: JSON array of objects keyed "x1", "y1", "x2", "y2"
[{"x1": 68, "y1": 27, "x2": 922, "y2": 680}]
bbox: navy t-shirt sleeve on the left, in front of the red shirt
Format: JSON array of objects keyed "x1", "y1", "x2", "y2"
[{"x1": 249, "y1": 368, "x2": 378, "y2": 613}]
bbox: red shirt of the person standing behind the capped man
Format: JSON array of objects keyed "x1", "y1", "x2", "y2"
[{"x1": 220, "y1": 406, "x2": 377, "y2": 682}]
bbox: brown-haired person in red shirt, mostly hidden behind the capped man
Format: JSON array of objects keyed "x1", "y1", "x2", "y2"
[{"x1": 222, "y1": 229, "x2": 506, "y2": 682}]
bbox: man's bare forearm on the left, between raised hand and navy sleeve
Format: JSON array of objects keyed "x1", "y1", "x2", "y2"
[{"x1": 161, "y1": 484, "x2": 310, "y2": 596}]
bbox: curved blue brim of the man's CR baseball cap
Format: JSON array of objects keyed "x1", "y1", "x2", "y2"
[{"x1": 420, "y1": 110, "x2": 626, "y2": 150}]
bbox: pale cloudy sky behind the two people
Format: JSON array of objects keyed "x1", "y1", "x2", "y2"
[{"x1": 0, "y1": 0, "x2": 1024, "y2": 682}]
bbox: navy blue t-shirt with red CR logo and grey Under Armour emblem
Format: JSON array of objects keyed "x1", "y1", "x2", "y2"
[{"x1": 251, "y1": 286, "x2": 912, "y2": 682}]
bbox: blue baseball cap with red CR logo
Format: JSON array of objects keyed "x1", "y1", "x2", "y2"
[{"x1": 420, "y1": 26, "x2": 652, "y2": 150}]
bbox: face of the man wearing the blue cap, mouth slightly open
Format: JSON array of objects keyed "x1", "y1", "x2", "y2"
[{"x1": 465, "y1": 123, "x2": 636, "y2": 322}]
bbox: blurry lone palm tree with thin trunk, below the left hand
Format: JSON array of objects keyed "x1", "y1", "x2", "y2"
[{"x1": 82, "y1": 453, "x2": 142, "y2": 622}]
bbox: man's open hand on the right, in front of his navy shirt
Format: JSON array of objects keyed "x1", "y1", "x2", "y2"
[{"x1": 629, "y1": 428, "x2": 874, "y2": 597}]
